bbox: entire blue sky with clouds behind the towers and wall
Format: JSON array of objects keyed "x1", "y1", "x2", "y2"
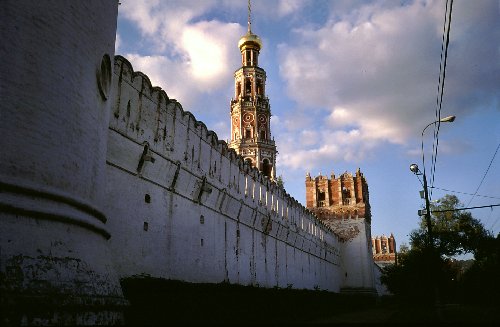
[{"x1": 116, "y1": 0, "x2": 500, "y2": 252}]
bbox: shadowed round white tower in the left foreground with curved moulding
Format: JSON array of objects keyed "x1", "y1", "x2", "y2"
[{"x1": 0, "y1": 0, "x2": 125, "y2": 325}]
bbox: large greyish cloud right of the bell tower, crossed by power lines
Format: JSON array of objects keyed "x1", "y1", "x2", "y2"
[{"x1": 279, "y1": 1, "x2": 500, "y2": 169}]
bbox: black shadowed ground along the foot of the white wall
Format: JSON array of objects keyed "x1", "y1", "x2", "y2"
[{"x1": 122, "y1": 278, "x2": 500, "y2": 326}]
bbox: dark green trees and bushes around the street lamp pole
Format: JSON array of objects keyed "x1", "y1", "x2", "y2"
[{"x1": 381, "y1": 195, "x2": 500, "y2": 304}]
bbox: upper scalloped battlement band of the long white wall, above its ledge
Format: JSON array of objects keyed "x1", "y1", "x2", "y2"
[{"x1": 110, "y1": 55, "x2": 331, "y2": 238}]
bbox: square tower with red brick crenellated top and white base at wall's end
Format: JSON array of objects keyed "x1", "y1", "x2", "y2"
[{"x1": 305, "y1": 168, "x2": 375, "y2": 293}]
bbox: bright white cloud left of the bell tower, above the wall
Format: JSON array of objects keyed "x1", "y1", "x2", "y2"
[{"x1": 120, "y1": 0, "x2": 244, "y2": 108}]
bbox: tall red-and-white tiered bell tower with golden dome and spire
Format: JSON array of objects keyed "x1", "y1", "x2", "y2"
[{"x1": 229, "y1": 1, "x2": 278, "y2": 179}]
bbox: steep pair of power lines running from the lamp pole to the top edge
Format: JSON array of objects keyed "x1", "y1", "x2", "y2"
[{"x1": 430, "y1": 0, "x2": 453, "y2": 197}]
